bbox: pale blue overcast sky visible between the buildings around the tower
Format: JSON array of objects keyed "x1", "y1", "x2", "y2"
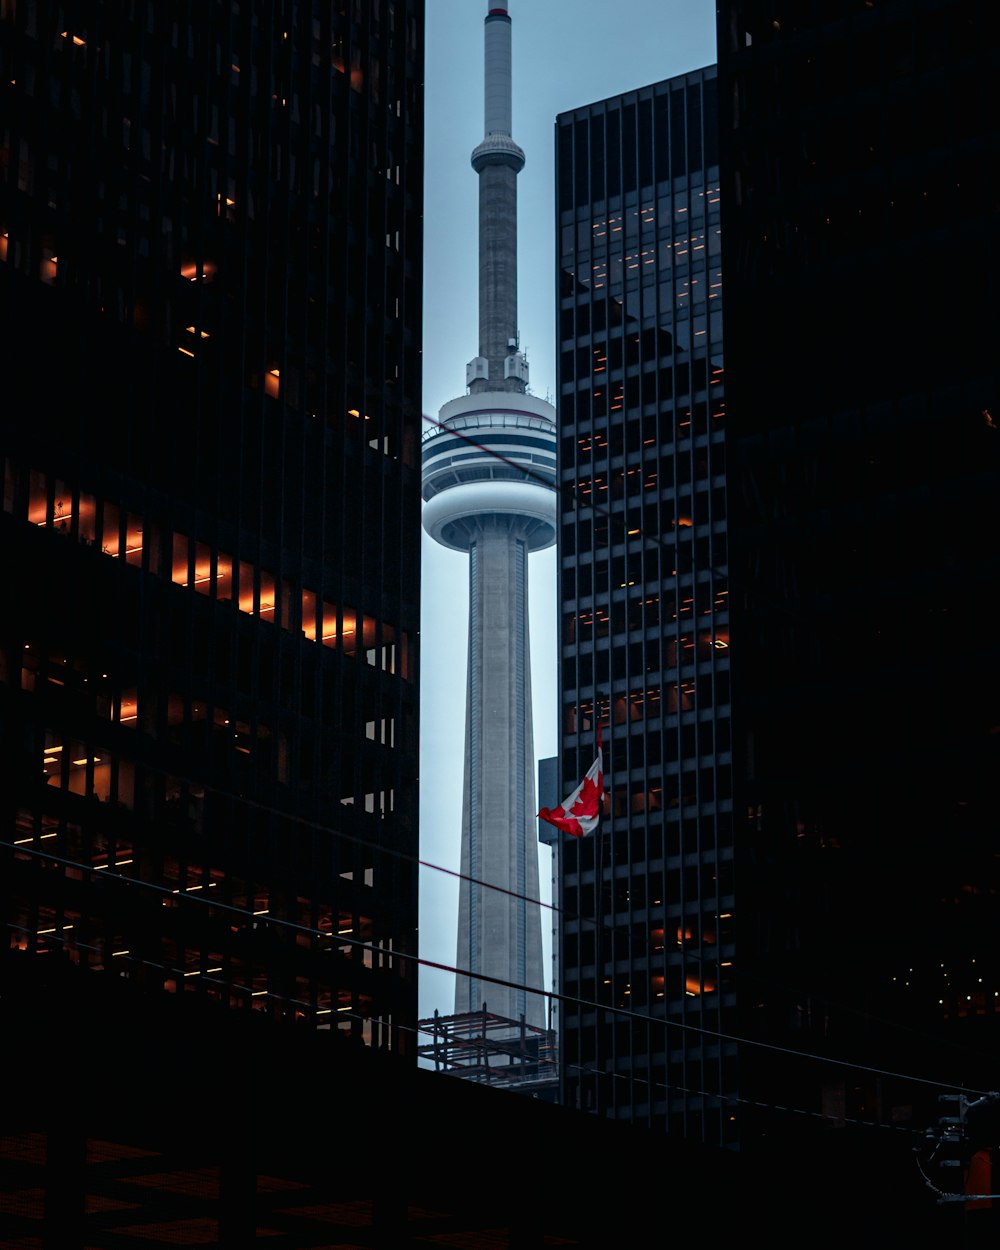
[{"x1": 420, "y1": 0, "x2": 715, "y2": 1016}]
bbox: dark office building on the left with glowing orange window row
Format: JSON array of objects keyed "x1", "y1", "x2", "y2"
[{"x1": 0, "y1": 0, "x2": 424, "y2": 1055}]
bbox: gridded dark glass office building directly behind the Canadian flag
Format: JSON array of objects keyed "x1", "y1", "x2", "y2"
[{"x1": 556, "y1": 69, "x2": 736, "y2": 1144}]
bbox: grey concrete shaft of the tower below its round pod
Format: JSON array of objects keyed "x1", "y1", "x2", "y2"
[{"x1": 455, "y1": 518, "x2": 545, "y2": 1026}]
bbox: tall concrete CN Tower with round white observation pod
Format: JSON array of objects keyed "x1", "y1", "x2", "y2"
[{"x1": 423, "y1": 0, "x2": 556, "y2": 1028}]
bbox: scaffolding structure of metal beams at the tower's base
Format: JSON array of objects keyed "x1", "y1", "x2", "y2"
[{"x1": 418, "y1": 1005, "x2": 559, "y2": 1100}]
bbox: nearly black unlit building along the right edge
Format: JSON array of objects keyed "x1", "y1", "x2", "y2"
[{"x1": 719, "y1": 0, "x2": 1000, "y2": 1170}]
